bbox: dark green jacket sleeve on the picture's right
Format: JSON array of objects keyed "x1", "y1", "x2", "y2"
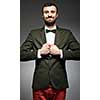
[{"x1": 63, "y1": 32, "x2": 80, "y2": 60}]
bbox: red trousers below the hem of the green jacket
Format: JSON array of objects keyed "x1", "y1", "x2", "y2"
[{"x1": 33, "y1": 87, "x2": 66, "y2": 100}]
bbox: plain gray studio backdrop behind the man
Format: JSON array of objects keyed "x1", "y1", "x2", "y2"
[{"x1": 20, "y1": 0, "x2": 80, "y2": 100}]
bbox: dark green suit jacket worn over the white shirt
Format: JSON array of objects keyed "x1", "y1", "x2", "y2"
[{"x1": 20, "y1": 27, "x2": 80, "y2": 89}]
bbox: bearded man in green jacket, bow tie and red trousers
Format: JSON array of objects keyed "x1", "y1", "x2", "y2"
[{"x1": 20, "y1": 3, "x2": 80, "y2": 100}]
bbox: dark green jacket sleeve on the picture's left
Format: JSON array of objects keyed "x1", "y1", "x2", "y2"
[{"x1": 20, "y1": 33, "x2": 37, "y2": 61}]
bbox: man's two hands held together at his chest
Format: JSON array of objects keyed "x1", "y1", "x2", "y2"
[{"x1": 40, "y1": 43, "x2": 60, "y2": 55}]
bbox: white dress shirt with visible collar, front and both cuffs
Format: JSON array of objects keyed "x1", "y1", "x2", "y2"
[{"x1": 37, "y1": 26, "x2": 63, "y2": 58}]
